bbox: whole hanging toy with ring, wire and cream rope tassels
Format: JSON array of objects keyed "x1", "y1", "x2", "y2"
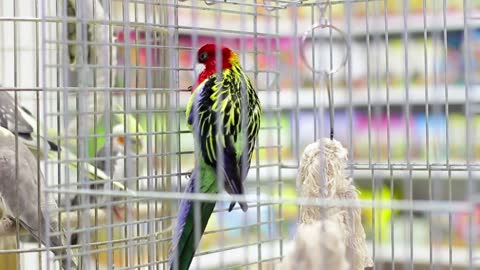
[{"x1": 281, "y1": 1, "x2": 373, "y2": 270}]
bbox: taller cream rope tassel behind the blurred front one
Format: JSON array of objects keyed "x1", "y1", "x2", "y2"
[{"x1": 297, "y1": 138, "x2": 373, "y2": 270}]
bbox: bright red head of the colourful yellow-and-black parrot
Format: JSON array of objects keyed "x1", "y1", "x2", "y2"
[{"x1": 192, "y1": 44, "x2": 239, "y2": 91}]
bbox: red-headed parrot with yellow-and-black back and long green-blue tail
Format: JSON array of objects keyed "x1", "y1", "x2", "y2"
[{"x1": 169, "y1": 44, "x2": 262, "y2": 270}]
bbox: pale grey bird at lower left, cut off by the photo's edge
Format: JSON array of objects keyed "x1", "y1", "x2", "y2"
[{"x1": 0, "y1": 127, "x2": 77, "y2": 270}]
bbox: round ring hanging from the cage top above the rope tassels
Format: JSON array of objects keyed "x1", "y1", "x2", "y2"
[{"x1": 300, "y1": 23, "x2": 349, "y2": 76}]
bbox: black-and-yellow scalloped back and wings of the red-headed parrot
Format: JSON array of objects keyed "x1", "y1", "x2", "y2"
[{"x1": 187, "y1": 61, "x2": 262, "y2": 210}]
